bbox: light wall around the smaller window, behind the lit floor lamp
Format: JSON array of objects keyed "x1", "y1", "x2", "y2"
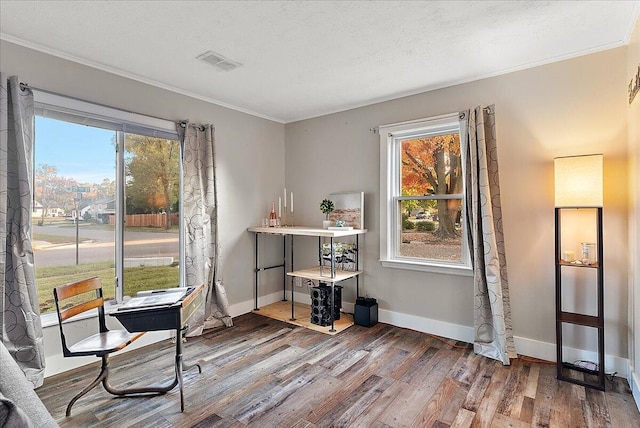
[{"x1": 285, "y1": 48, "x2": 628, "y2": 369}]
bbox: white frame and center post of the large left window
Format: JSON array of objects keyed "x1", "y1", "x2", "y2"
[{"x1": 33, "y1": 90, "x2": 186, "y2": 310}]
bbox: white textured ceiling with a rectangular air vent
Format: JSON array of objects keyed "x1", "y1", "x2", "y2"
[{"x1": 0, "y1": 0, "x2": 640, "y2": 122}]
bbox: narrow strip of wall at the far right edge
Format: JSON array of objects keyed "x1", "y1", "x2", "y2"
[{"x1": 625, "y1": 15, "x2": 640, "y2": 407}]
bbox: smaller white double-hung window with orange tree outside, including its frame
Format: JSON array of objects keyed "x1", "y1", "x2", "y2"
[{"x1": 380, "y1": 114, "x2": 470, "y2": 274}]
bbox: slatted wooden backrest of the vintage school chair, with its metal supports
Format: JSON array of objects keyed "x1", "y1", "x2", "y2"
[{"x1": 53, "y1": 277, "x2": 108, "y2": 356}]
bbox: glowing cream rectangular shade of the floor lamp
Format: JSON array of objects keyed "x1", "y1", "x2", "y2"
[{"x1": 554, "y1": 155, "x2": 602, "y2": 207}]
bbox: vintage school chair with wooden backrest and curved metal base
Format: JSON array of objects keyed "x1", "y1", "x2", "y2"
[{"x1": 53, "y1": 277, "x2": 173, "y2": 416}]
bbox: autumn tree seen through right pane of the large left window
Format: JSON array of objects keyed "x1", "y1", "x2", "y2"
[{"x1": 125, "y1": 134, "x2": 180, "y2": 228}]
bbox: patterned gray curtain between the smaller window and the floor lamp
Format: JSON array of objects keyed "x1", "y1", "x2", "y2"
[{"x1": 460, "y1": 105, "x2": 517, "y2": 365}]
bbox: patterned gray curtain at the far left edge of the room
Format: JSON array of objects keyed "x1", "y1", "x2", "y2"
[{"x1": 0, "y1": 73, "x2": 45, "y2": 388}]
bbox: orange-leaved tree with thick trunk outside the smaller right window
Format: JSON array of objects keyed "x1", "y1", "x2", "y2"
[{"x1": 402, "y1": 133, "x2": 462, "y2": 239}]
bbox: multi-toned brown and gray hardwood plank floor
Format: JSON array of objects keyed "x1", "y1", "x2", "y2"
[{"x1": 37, "y1": 313, "x2": 640, "y2": 428}]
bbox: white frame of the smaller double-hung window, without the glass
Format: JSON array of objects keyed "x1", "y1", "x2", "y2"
[{"x1": 379, "y1": 113, "x2": 473, "y2": 276}]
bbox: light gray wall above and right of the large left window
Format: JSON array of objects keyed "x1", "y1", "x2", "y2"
[{"x1": 0, "y1": 41, "x2": 284, "y2": 375}]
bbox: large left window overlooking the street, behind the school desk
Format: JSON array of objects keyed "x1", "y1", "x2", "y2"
[{"x1": 32, "y1": 93, "x2": 181, "y2": 314}]
